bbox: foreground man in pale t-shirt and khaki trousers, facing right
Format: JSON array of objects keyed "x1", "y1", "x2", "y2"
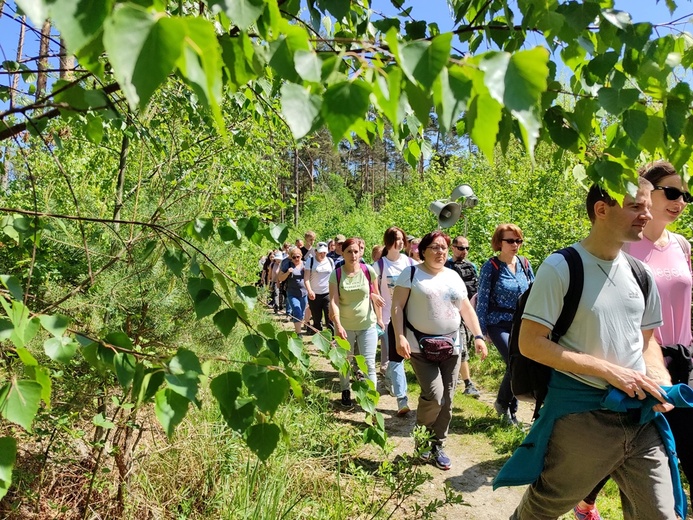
[{"x1": 508, "y1": 178, "x2": 676, "y2": 520}]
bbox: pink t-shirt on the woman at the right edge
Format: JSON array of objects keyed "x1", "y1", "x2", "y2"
[{"x1": 623, "y1": 233, "x2": 693, "y2": 345}]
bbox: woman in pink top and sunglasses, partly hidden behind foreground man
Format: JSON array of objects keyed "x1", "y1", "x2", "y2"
[{"x1": 573, "y1": 161, "x2": 693, "y2": 520}]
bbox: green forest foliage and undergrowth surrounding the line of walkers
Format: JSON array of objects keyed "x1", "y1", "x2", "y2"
[{"x1": 0, "y1": 0, "x2": 693, "y2": 518}]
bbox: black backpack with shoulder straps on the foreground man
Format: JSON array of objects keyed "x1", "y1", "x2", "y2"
[{"x1": 509, "y1": 247, "x2": 650, "y2": 419}]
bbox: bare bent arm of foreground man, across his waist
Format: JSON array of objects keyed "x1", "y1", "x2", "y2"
[{"x1": 520, "y1": 320, "x2": 671, "y2": 411}]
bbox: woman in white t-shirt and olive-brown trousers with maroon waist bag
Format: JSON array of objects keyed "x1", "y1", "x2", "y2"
[{"x1": 392, "y1": 231, "x2": 488, "y2": 470}]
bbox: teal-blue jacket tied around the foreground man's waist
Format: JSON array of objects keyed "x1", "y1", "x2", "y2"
[{"x1": 493, "y1": 371, "x2": 693, "y2": 518}]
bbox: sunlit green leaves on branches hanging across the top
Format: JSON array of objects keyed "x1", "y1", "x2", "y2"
[{"x1": 9, "y1": 0, "x2": 693, "y2": 192}]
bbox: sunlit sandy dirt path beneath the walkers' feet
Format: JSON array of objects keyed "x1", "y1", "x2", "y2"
[{"x1": 285, "y1": 310, "x2": 531, "y2": 520}]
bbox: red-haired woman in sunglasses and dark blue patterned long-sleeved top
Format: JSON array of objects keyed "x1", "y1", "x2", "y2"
[{"x1": 476, "y1": 224, "x2": 534, "y2": 426}]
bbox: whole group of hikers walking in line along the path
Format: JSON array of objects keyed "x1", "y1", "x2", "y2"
[{"x1": 263, "y1": 161, "x2": 693, "y2": 520}]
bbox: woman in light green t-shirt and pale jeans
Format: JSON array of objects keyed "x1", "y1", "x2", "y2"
[{"x1": 329, "y1": 238, "x2": 383, "y2": 406}]
